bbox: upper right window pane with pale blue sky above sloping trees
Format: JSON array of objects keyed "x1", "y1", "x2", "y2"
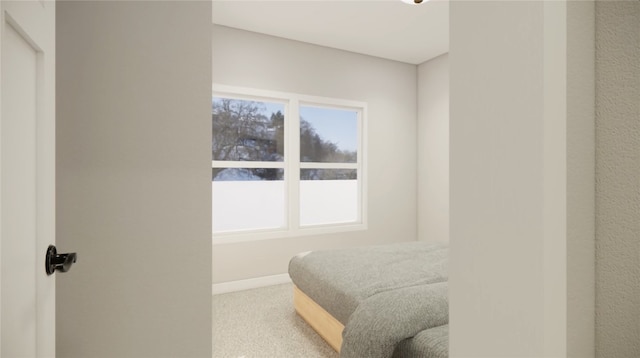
[{"x1": 300, "y1": 106, "x2": 358, "y2": 163}]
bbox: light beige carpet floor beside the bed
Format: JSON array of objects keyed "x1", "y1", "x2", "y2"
[{"x1": 213, "y1": 284, "x2": 338, "y2": 358}]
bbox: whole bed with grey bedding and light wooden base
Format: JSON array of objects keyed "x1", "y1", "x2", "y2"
[{"x1": 289, "y1": 242, "x2": 449, "y2": 358}]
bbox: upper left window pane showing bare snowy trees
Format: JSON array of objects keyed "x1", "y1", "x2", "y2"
[{"x1": 211, "y1": 97, "x2": 285, "y2": 162}]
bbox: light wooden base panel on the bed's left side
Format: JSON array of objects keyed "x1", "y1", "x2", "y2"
[{"x1": 293, "y1": 285, "x2": 344, "y2": 353}]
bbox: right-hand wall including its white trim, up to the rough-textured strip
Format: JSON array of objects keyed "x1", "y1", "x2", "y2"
[{"x1": 449, "y1": 1, "x2": 594, "y2": 357}]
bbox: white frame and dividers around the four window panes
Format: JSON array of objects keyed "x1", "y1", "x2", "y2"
[{"x1": 211, "y1": 84, "x2": 368, "y2": 245}]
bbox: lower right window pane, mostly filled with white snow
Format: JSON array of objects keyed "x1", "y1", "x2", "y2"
[{"x1": 300, "y1": 169, "x2": 358, "y2": 226}]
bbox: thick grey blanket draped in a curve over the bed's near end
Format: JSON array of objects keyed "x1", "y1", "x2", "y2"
[{"x1": 340, "y1": 282, "x2": 449, "y2": 358}]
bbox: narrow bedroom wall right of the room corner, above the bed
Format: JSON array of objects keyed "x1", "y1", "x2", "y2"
[{"x1": 418, "y1": 54, "x2": 449, "y2": 241}]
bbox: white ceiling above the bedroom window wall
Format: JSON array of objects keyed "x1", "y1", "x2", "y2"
[{"x1": 213, "y1": 0, "x2": 449, "y2": 64}]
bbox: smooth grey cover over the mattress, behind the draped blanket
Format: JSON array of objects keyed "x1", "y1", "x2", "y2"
[{"x1": 289, "y1": 242, "x2": 449, "y2": 325}]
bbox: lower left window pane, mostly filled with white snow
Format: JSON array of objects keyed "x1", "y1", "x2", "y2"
[{"x1": 211, "y1": 168, "x2": 285, "y2": 233}]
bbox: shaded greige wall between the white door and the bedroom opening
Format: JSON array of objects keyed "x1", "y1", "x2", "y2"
[{"x1": 56, "y1": 1, "x2": 212, "y2": 358}]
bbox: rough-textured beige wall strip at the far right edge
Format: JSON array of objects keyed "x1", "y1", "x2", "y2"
[{"x1": 596, "y1": 1, "x2": 640, "y2": 358}]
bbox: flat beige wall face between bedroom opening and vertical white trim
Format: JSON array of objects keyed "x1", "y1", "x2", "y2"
[{"x1": 449, "y1": 2, "x2": 545, "y2": 357}]
